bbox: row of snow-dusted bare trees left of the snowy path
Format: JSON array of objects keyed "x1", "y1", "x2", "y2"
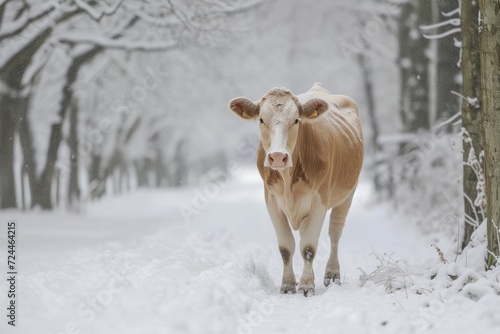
[{"x1": 0, "y1": 0, "x2": 258, "y2": 209}]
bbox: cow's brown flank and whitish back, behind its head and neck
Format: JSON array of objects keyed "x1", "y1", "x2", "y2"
[{"x1": 296, "y1": 84, "x2": 363, "y2": 207}]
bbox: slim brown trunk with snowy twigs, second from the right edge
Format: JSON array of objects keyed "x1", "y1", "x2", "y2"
[{"x1": 460, "y1": 0, "x2": 484, "y2": 249}]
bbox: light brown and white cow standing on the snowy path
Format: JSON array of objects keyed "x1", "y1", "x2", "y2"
[{"x1": 229, "y1": 83, "x2": 363, "y2": 296}]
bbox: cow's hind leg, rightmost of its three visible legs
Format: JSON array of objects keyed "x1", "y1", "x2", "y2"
[{"x1": 323, "y1": 193, "x2": 354, "y2": 286}]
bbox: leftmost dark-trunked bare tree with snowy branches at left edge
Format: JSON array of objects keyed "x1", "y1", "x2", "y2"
[{"x1": 0, "y1": 0, "x2": 99, "y2": 208}]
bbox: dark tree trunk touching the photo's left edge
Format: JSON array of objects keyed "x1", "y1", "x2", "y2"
[{"x1": 0, "y1": 93, "x2": 18, "y2": 209}]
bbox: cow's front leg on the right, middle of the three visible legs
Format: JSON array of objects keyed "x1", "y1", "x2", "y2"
[{"x1": 299, "y1": 205, "x2": 326, "y2": 297}]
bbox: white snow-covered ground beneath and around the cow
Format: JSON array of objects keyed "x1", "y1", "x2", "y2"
[{"x1": 0, "y1": 167, "x2": 500, "y2": 334}]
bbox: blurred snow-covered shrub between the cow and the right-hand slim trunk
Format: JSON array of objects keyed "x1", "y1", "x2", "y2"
[{"x1": 380, "y1": 124, "x2": 463, "y2": 237}]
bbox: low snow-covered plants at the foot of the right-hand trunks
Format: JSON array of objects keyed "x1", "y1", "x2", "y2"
[{"x1": 359, "y1": 220, "x2": 500, "y2": 301}]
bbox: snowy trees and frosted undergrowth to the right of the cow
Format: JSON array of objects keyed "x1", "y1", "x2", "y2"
[{"x1": 352, "y1": 0, "x2": 500, "y2": 265}]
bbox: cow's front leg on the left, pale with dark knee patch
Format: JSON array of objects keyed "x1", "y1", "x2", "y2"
[{"x1": 267, "y1": 198, "x2": 297, "y2": 293}]
